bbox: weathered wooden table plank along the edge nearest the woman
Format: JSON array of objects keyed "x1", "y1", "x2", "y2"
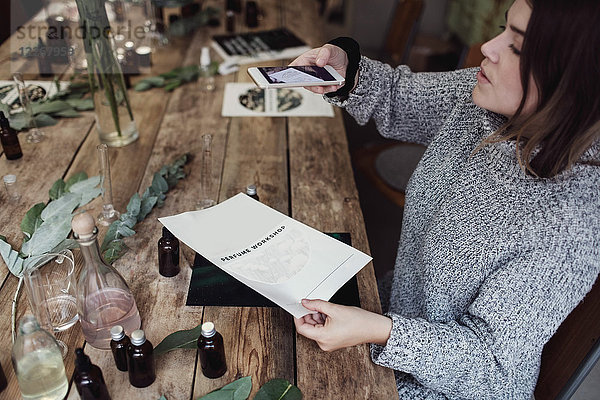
[{"x1": 284, "y1": 1, "x2": 398, "y2": 399}]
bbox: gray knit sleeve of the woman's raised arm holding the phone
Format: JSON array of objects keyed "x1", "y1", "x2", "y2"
[{"x1": 324, "y1": 56, "x2": 477, "y2": 145}]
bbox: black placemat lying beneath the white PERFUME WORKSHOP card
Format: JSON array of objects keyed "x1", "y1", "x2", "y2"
[{"x1": 186, "y1": 232, "x2": 360, "y2": 307}]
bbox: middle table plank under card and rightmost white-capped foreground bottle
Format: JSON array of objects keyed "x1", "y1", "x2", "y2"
[{"x1": 193, "y1": 1, "x2": 295, "y2": 398}]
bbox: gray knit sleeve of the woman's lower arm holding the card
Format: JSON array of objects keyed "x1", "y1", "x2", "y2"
[{"x1": 371, "y1": 233, "x2": 600, "y2": 399}]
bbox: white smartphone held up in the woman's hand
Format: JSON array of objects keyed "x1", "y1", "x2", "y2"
[{"x1": 248, "y1": 65, "x2": 344, "y2": 89}]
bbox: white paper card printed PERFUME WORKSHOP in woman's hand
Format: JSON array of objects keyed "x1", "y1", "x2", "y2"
[{"x1": 158, "y1": 193, "x2": 371, "y2": 318}]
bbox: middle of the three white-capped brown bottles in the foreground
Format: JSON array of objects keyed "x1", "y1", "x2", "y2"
[{"x1": 127, "y1": 329, "x2": 156, "y2": 387}]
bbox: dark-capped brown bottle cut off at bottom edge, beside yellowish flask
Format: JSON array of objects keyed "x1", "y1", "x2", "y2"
[{"x1": 73, "y1": 349, "x2": 111, "y2": 400}]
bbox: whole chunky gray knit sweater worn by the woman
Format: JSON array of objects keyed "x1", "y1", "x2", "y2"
[{"x1": 329, "y1": 57, "x2": 600, "y2": 400}]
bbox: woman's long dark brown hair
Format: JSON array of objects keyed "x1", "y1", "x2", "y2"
[{"x1": 490, "y1": 0, "x2": 600, "y2": 178}]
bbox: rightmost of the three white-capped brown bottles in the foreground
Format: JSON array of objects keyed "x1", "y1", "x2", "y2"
[{"x1": 198, "y1": 322, "x2": 227, "y2": 379}]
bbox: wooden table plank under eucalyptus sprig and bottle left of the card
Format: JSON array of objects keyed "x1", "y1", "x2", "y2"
[{"x1": 69, "y1": 19, "x2": 232, "y2": 399}]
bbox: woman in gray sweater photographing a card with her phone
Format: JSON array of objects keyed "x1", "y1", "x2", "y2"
[{"x1": 292, "y1": 0, "x2": 600, "y2": 399}]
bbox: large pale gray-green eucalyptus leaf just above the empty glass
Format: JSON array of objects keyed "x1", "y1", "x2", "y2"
[{"x1": 21, "y1": 212, "x2": 71, "y2": 256}]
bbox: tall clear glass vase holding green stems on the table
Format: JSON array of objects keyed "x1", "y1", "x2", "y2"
[{"x1": 76, "y1": 0, "x2": 139, "y2": 147}]
